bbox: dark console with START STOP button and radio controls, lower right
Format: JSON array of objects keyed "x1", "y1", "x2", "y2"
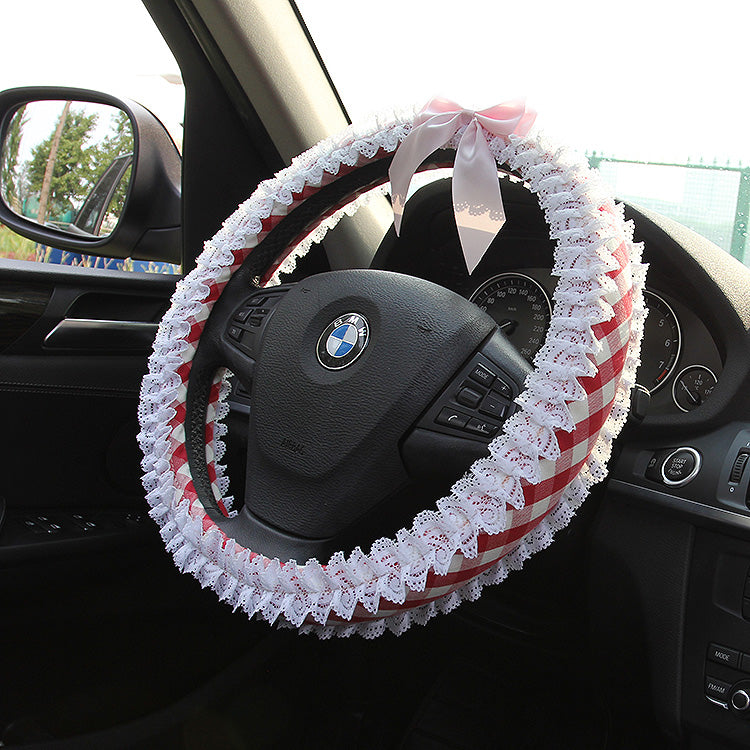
[{"x1": 604, "y1": 423, "x2": 750, "y2": 750}]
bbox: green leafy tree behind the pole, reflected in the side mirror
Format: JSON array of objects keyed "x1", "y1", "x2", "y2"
[{"x1": 28, "y1": 109, "x2": 97, "y2": 223}]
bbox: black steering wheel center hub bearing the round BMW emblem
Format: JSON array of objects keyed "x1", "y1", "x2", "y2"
[{"x1": 245, "y1": 270, "x2": 495, "y2": 538}]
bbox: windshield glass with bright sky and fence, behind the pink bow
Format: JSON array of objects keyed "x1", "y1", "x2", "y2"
[{"x1": 297, "y1": 0, "x2": 750, "y2": 265}]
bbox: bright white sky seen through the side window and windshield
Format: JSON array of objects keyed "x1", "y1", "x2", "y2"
[{"x1": 0, "y1": 0, "x2": 750, "y2": 164}]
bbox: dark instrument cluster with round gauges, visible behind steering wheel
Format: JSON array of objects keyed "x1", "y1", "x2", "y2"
[{"x1": 376, "y1": 180, "x2": 723, "y2": 416}]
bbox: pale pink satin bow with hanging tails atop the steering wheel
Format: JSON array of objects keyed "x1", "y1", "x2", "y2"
[{"x1": 388, "y1": 99, "x2": 536, "y2": 273}]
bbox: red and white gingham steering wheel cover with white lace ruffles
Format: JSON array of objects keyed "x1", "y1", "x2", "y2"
[{"x1": 139, "y1": 119, "x2": 645, "y2": 637}]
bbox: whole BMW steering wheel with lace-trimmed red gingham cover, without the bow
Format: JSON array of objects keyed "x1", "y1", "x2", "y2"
[{"x1": 139, "y1": 114, "x2": 645, "y2": 637}]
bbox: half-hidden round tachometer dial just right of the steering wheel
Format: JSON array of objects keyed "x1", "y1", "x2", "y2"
[{"x1": 636, "y1": 292, "x2": 682, "y2": 393}]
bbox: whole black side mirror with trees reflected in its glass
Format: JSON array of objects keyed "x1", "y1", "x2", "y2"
[{"x1": 0, "y1": 87, "x2": 181, "y2": 263}]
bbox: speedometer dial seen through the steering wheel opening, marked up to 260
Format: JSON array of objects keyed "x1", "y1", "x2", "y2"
[{"x1": 471, "y1": 273, "x2": 552, "y2": 362}]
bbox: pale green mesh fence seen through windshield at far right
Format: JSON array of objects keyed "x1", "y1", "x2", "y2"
[{"x1": 587, "y1": 152, "x2": 750, "y2": 265}]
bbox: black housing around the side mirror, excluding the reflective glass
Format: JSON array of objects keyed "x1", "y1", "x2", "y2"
[{"x1": 0, "y1": 86, "x2": 182, "y2": 263}]
